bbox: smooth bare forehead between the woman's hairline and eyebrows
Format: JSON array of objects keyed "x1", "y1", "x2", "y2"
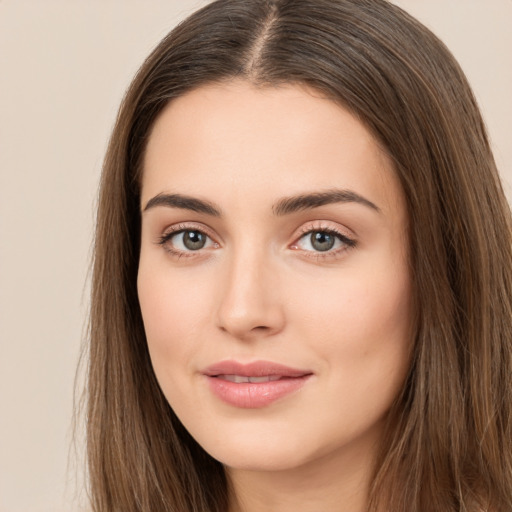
[{"x1": 142, "y1": 81, "x2": 401, "y2": 218}]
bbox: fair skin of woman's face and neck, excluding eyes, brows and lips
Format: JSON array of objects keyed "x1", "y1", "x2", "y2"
[{"x1": 138, "y1": 81, "x2": 411, "y2": 512}]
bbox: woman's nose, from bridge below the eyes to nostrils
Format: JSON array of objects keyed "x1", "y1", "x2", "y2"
[{"x1": 218, "y1": 247, "x2": 285, "y2": 340}]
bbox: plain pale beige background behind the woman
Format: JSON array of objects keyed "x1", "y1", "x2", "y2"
[{"x1": 0, "y1": 0, "x2": 512, "y2": 512}]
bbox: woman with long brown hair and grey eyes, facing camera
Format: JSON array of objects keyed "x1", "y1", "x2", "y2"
[{"x1": 88, "y1": 0, "x2": 512, "y2": 512}]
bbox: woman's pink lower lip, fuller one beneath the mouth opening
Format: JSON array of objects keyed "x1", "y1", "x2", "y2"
[{"x1": 207, "y1": 375, "x2": 311, "y2": 409}]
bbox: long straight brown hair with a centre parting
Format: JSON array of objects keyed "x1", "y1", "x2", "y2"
[{"x1": 87, "y1": 0, "x2": 512, "y2": 512}]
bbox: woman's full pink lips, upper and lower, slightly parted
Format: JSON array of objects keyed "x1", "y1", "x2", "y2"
[{"x1": 203, "y1": 361, "x2": 313, "y2": 409}]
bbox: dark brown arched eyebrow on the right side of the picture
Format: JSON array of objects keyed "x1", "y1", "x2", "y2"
[{"x1": 272, "y1": 189, "x2": 381, "y2": 216}]
